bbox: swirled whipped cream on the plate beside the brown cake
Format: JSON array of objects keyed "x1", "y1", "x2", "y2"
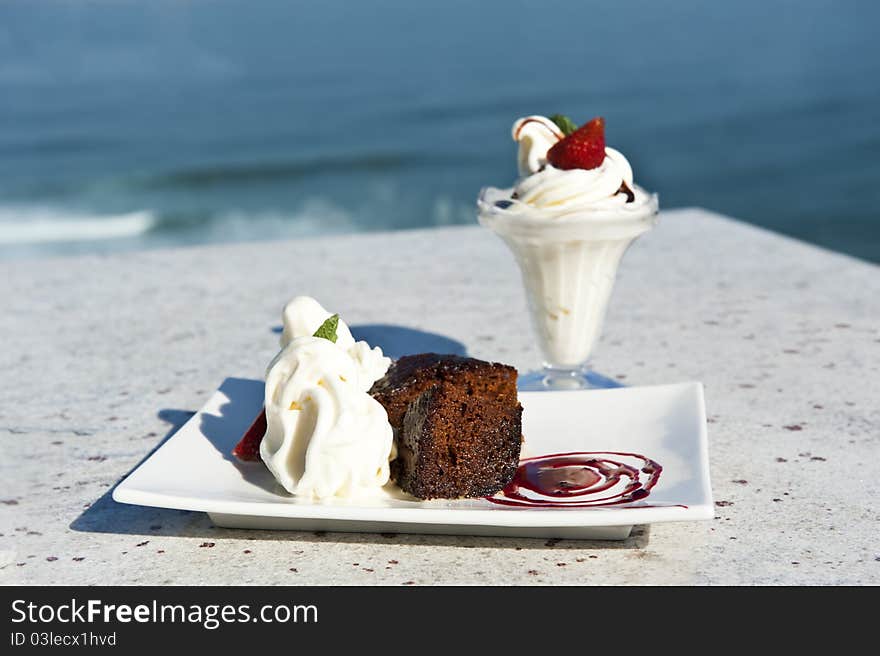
[{"x1": 260, "y1": 296, "x2": 396, "y2": 499}]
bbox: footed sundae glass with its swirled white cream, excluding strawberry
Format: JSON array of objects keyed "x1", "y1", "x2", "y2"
[{"x1": 477, "y1": 116, "x2": 658, "y2": 388}]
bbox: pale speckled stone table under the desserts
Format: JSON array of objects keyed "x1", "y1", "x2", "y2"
[{"x1": 0, "y1": 210, "x2": 880, "y2": 585}]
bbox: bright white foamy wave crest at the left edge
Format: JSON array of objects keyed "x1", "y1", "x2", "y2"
[{"x1": 0, "y1": 207, "x2": 157, "y2": 244}]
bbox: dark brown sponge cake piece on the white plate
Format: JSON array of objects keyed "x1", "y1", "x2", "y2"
[{"x1": 370, "y1": 353, "x2": 522, "y2": 499}]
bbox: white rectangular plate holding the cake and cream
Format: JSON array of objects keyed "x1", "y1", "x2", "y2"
[{"x1": 113, "y1": 378, "x2": 714, "y2": 540}]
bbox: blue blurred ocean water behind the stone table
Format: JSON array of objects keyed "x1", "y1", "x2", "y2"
[{"x1": 0, "y1": 0, "x2": 880, "y2": 262}]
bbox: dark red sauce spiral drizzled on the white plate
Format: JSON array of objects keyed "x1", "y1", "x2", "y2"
[{"x1": 486, "y1": 452, "x2": 663, "y2": 508}]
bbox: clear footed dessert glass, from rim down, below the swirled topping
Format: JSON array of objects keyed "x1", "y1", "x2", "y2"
[{"x1": 477, "y1": 187, "x2": 658, "y2": 389}]
